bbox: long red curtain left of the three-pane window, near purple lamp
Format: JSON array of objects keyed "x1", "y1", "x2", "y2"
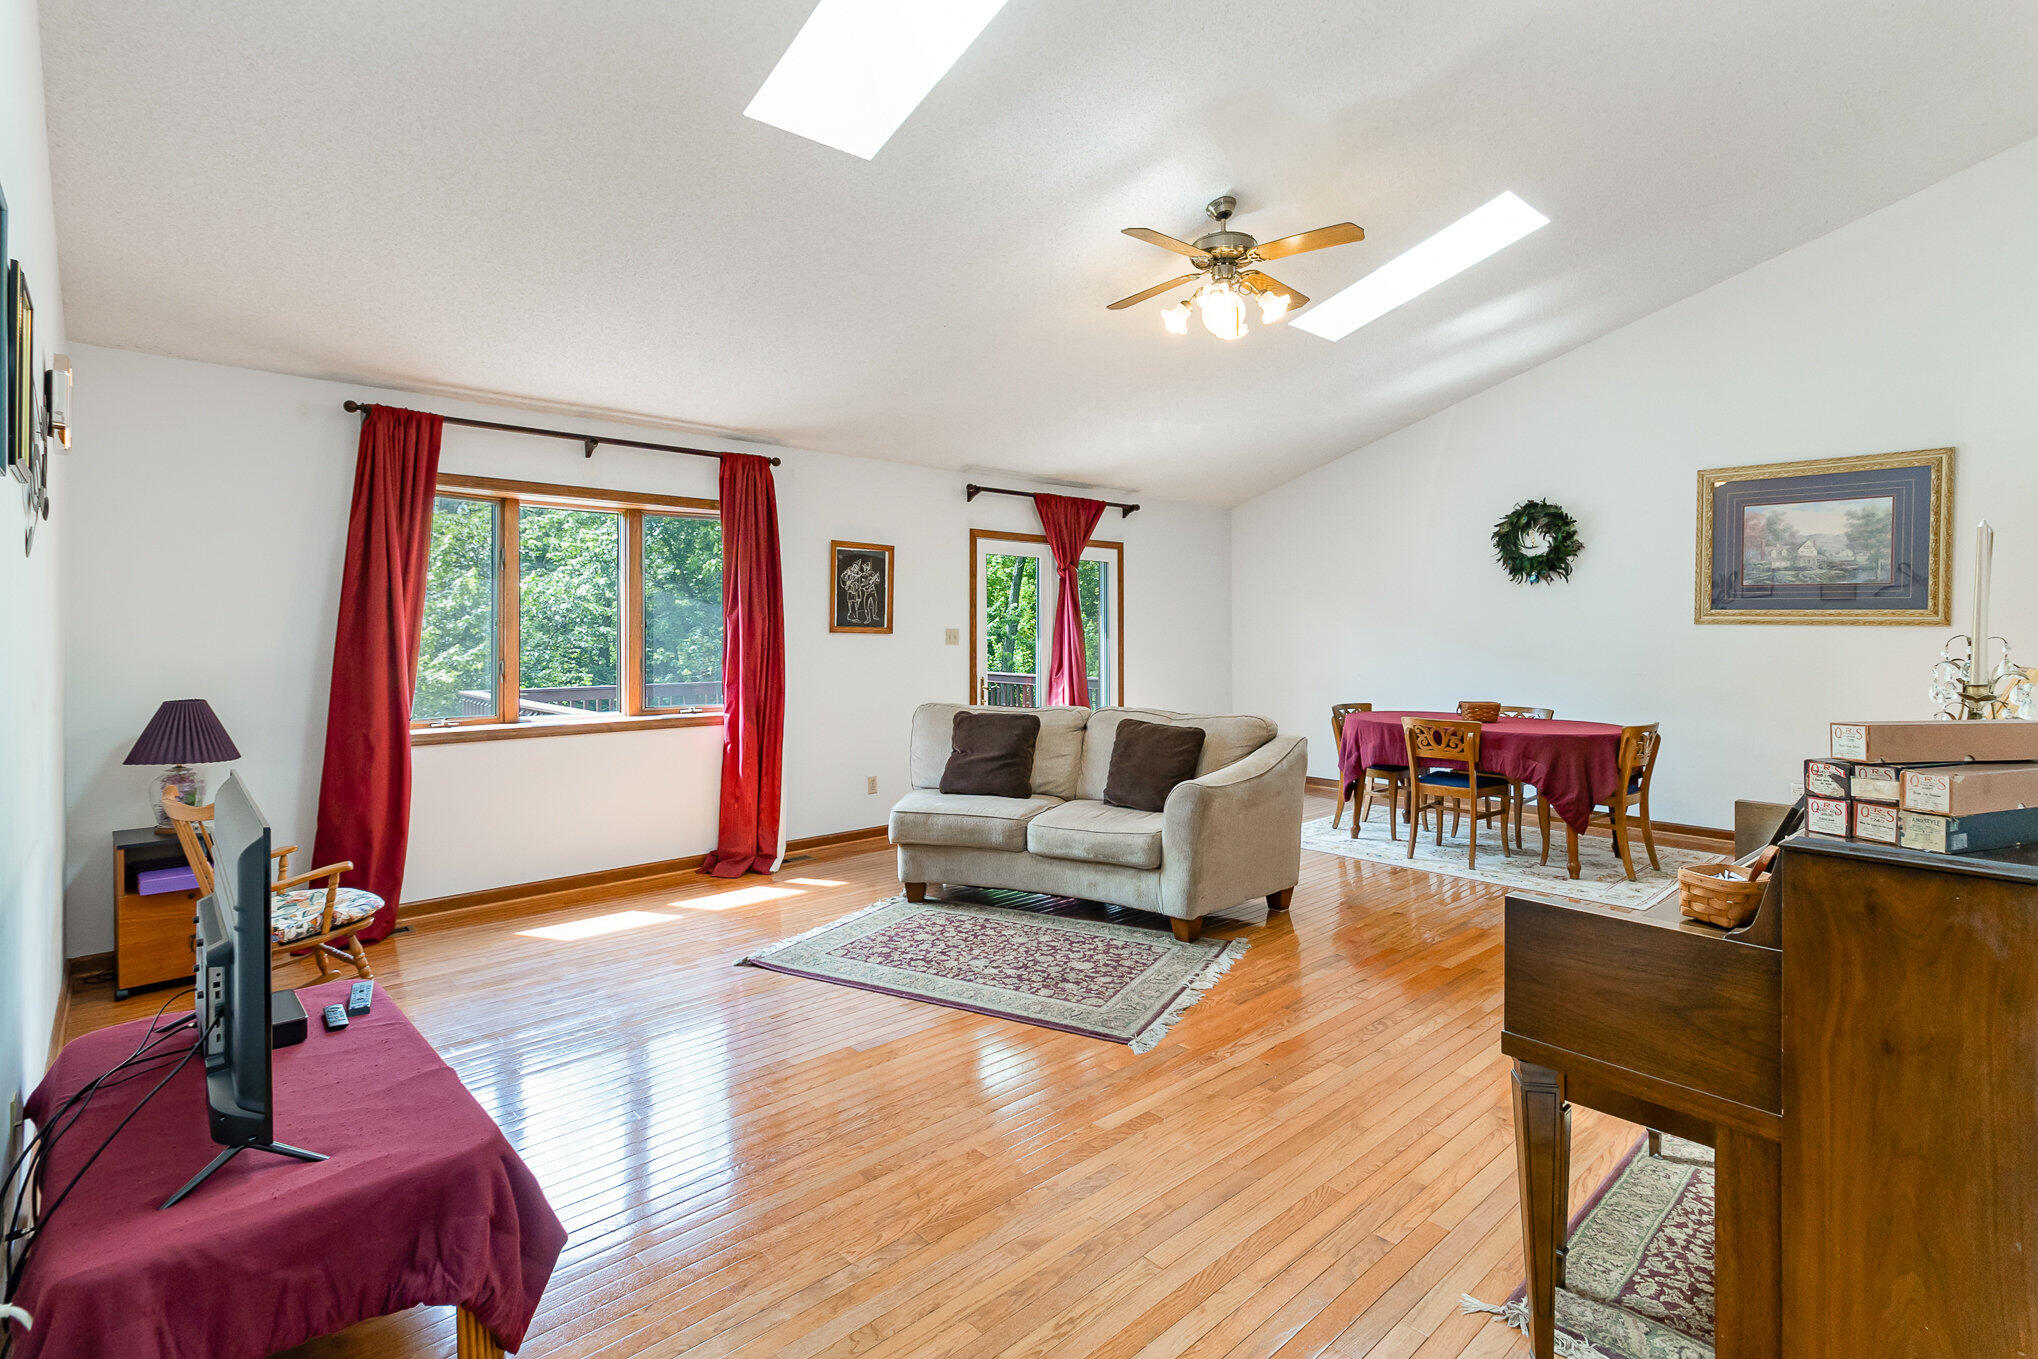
[{"x1": 312, "y1": 405, "x2": 444, "y2": 943}]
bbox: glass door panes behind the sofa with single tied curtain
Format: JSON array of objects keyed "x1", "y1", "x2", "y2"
[{"x1": 970, "y1": 530, "x2": 1125, "y2": 707}]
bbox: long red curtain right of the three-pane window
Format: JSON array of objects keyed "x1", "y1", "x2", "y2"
[{"x1": 701, "y1": 452, "x2": 785, "y2": 878}]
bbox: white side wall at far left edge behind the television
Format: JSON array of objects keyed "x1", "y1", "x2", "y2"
[{"x1": 0, "y1": 0, "x2": 73, "y2": 1124}]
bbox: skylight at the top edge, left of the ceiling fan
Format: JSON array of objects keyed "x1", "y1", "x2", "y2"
[{"x1": 744, "y1": 0, "x2": 1005, "y2": 161}]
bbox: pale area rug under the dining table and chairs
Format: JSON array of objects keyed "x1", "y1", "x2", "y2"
[{"x1": 1302, "y1": 807, "x2": 1724, "y2": 911}]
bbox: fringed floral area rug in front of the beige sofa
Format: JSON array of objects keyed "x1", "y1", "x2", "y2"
[{"x1": 742, "y1": 896, "x2": 1245, "y2": 1051}]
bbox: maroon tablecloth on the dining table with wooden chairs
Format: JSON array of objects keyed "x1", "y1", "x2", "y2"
[{"x1": 1337, "y1": 711, "x2": 1620, "y2": 831}]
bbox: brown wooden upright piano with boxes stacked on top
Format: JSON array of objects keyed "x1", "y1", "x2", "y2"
[{"x1": 1502, "y1": 835, "x2": 2038, "y2": 1359}]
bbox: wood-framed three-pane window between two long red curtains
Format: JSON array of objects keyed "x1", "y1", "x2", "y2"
[{"x1": 412, "y1": 477, "x2": 721, "y2": 742}]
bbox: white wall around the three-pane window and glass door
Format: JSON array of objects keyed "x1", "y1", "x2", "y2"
[{"x1": 65, "y1": 356, "x2": 1231, "y2": 956}]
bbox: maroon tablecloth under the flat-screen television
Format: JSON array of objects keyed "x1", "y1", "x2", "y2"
[{"x1": 14, "y1": 982, "x2": 567, "y2": 1359}]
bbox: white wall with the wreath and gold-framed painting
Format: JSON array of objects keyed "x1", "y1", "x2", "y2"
[{"x1": 1231, "y1": 143, "x2": 2038, "y2": 825}]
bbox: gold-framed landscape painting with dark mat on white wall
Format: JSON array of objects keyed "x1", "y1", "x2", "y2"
[{"x1": 1692, "y1": 448, "x2": 1952, "y2": 626}]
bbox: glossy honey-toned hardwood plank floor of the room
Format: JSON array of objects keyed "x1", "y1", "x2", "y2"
[{"x1": 69, "y1": 795, "x2": 1639, "y2": 1359}]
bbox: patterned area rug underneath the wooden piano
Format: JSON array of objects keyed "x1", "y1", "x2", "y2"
[{"x1": 1463, "y1": 1137, "x2": 1712, "y2": 1359}]
